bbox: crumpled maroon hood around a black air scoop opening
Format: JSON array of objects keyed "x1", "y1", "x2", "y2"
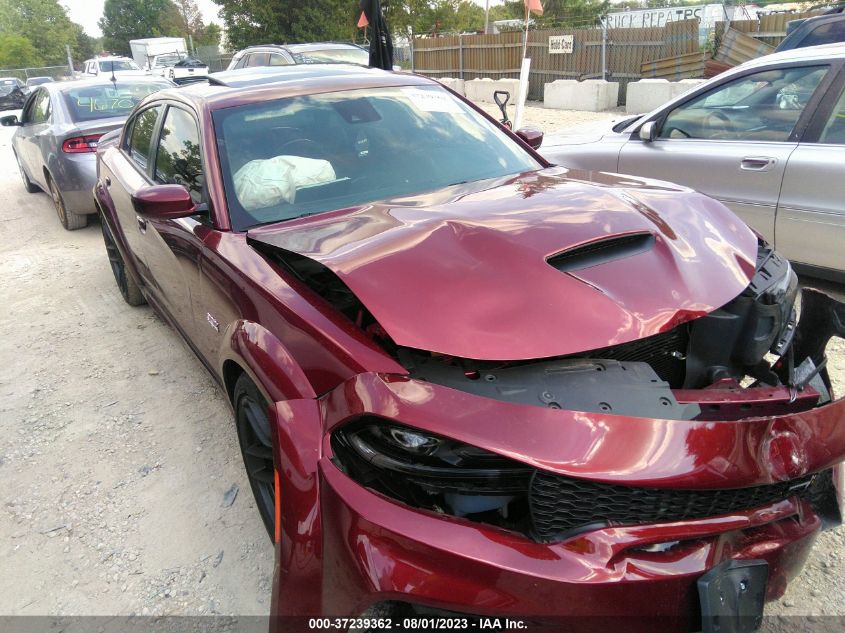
[{"x1": 248, "y1": 167, "x2": 757, "y2": 360}]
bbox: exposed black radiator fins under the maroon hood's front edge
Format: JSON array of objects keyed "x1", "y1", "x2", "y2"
[{"x1": 579, "y1": 324, "x2": 689, "y2": 388}]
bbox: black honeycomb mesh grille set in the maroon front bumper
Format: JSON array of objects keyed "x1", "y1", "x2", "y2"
[{"x1": 529, "y1": 471, "x2": 814, "y2": 541}]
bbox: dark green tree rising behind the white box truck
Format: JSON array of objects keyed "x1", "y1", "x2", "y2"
[{"x1": 99, "y1": 0, "x2": 185, "y2": 55}]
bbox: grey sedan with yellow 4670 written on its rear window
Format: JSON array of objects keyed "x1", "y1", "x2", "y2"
[{"x1": 0, "y1": 77, "x2": 173, "y2": 230}]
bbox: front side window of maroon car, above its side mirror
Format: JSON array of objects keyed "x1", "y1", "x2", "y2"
[{"x1": 155, "y1": 107, "x2": 205, "y2": 203}]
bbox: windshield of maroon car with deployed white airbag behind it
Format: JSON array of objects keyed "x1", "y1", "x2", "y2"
[{"x1": 214, "y1": 86, "x2": 541, "y2": 230}]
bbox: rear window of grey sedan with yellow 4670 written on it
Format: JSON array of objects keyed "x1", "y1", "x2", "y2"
[{"x1": 63, "y1": 81, "x2": 172, "y2": 121}]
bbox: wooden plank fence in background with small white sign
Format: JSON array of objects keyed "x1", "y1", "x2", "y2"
[{"x1": 413, "y1": 20, "x2": 699, "y2": 99}]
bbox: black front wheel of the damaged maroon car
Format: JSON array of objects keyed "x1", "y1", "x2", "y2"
[{"x1": 234, "y1": 374, "x2": 276, "y2": 540}]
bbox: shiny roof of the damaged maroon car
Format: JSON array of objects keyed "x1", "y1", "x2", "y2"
[{"x1": 160, "y1": 64, "x2": 437, "y2": 110}]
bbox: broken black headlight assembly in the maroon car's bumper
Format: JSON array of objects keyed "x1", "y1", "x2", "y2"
[{"x1": 332, "y1": 416, "x2": 534, "y2": 532}]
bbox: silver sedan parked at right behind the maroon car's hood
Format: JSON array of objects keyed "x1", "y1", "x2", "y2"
[{"x1": 541, "y1": 44, "x2": 845, "y2": 280}]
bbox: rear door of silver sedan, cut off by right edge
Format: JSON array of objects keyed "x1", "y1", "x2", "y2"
[{"x1": 775, "y1": 66, "x2": 845, "y2": 272}]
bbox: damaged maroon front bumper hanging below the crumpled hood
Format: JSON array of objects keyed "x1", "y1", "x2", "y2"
[{"x1": 273, "y1": 291, "x2": 845, "y2": 631}]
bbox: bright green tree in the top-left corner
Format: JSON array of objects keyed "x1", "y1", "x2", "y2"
[{"x1": 0, "y1": 0, "x2": 78, "y2": 68}]
